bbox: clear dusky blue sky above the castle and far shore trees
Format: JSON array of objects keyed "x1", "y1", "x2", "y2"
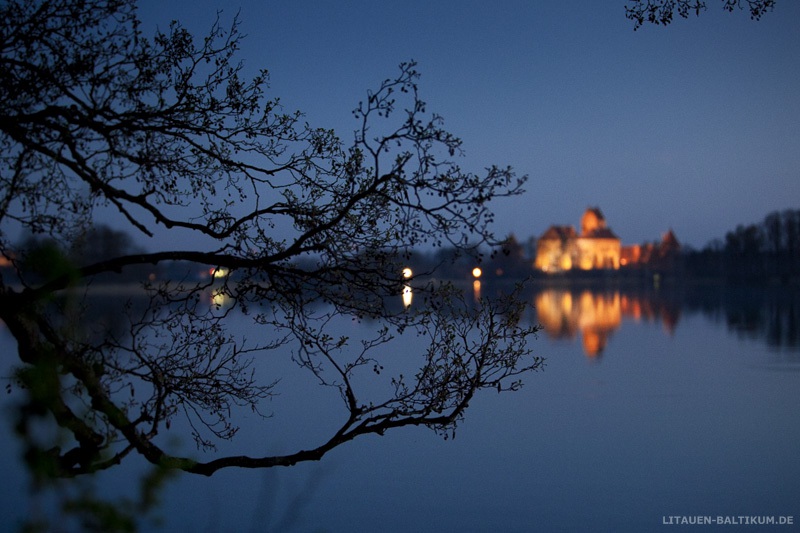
[{"x1": 134, "y1": 0, "x2": 800, "y2": 248}]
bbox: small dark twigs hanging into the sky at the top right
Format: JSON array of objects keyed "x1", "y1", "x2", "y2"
[{"x1": 625, "y1": 0, "x2": 775, "y2": 30}]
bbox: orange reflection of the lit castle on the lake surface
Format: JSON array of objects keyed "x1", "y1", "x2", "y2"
[{"x1": 533, "y1": 288, "x2": 680, "y2": 357}]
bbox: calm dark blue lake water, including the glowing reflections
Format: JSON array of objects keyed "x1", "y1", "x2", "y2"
[{"x1": 0, "y1": 280, "x2": 800, "y2": 532}]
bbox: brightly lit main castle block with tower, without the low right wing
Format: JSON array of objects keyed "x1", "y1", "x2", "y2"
[{"x1": 534, "y1": 207, "x2": 622, "y2": 272}]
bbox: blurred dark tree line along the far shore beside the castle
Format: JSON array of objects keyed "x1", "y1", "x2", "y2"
[{"x1": 10, "y1": 209, "x2": 800, "y2": 284}]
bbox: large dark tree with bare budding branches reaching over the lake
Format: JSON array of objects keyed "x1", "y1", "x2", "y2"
[{"x1": 0, "y1": 0, "x2": 542, "y2": 520}]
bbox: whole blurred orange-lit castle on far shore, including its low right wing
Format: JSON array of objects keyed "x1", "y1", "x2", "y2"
[{"x1": 533, "y1": 207, "x2": 680, "y2": 273}]
